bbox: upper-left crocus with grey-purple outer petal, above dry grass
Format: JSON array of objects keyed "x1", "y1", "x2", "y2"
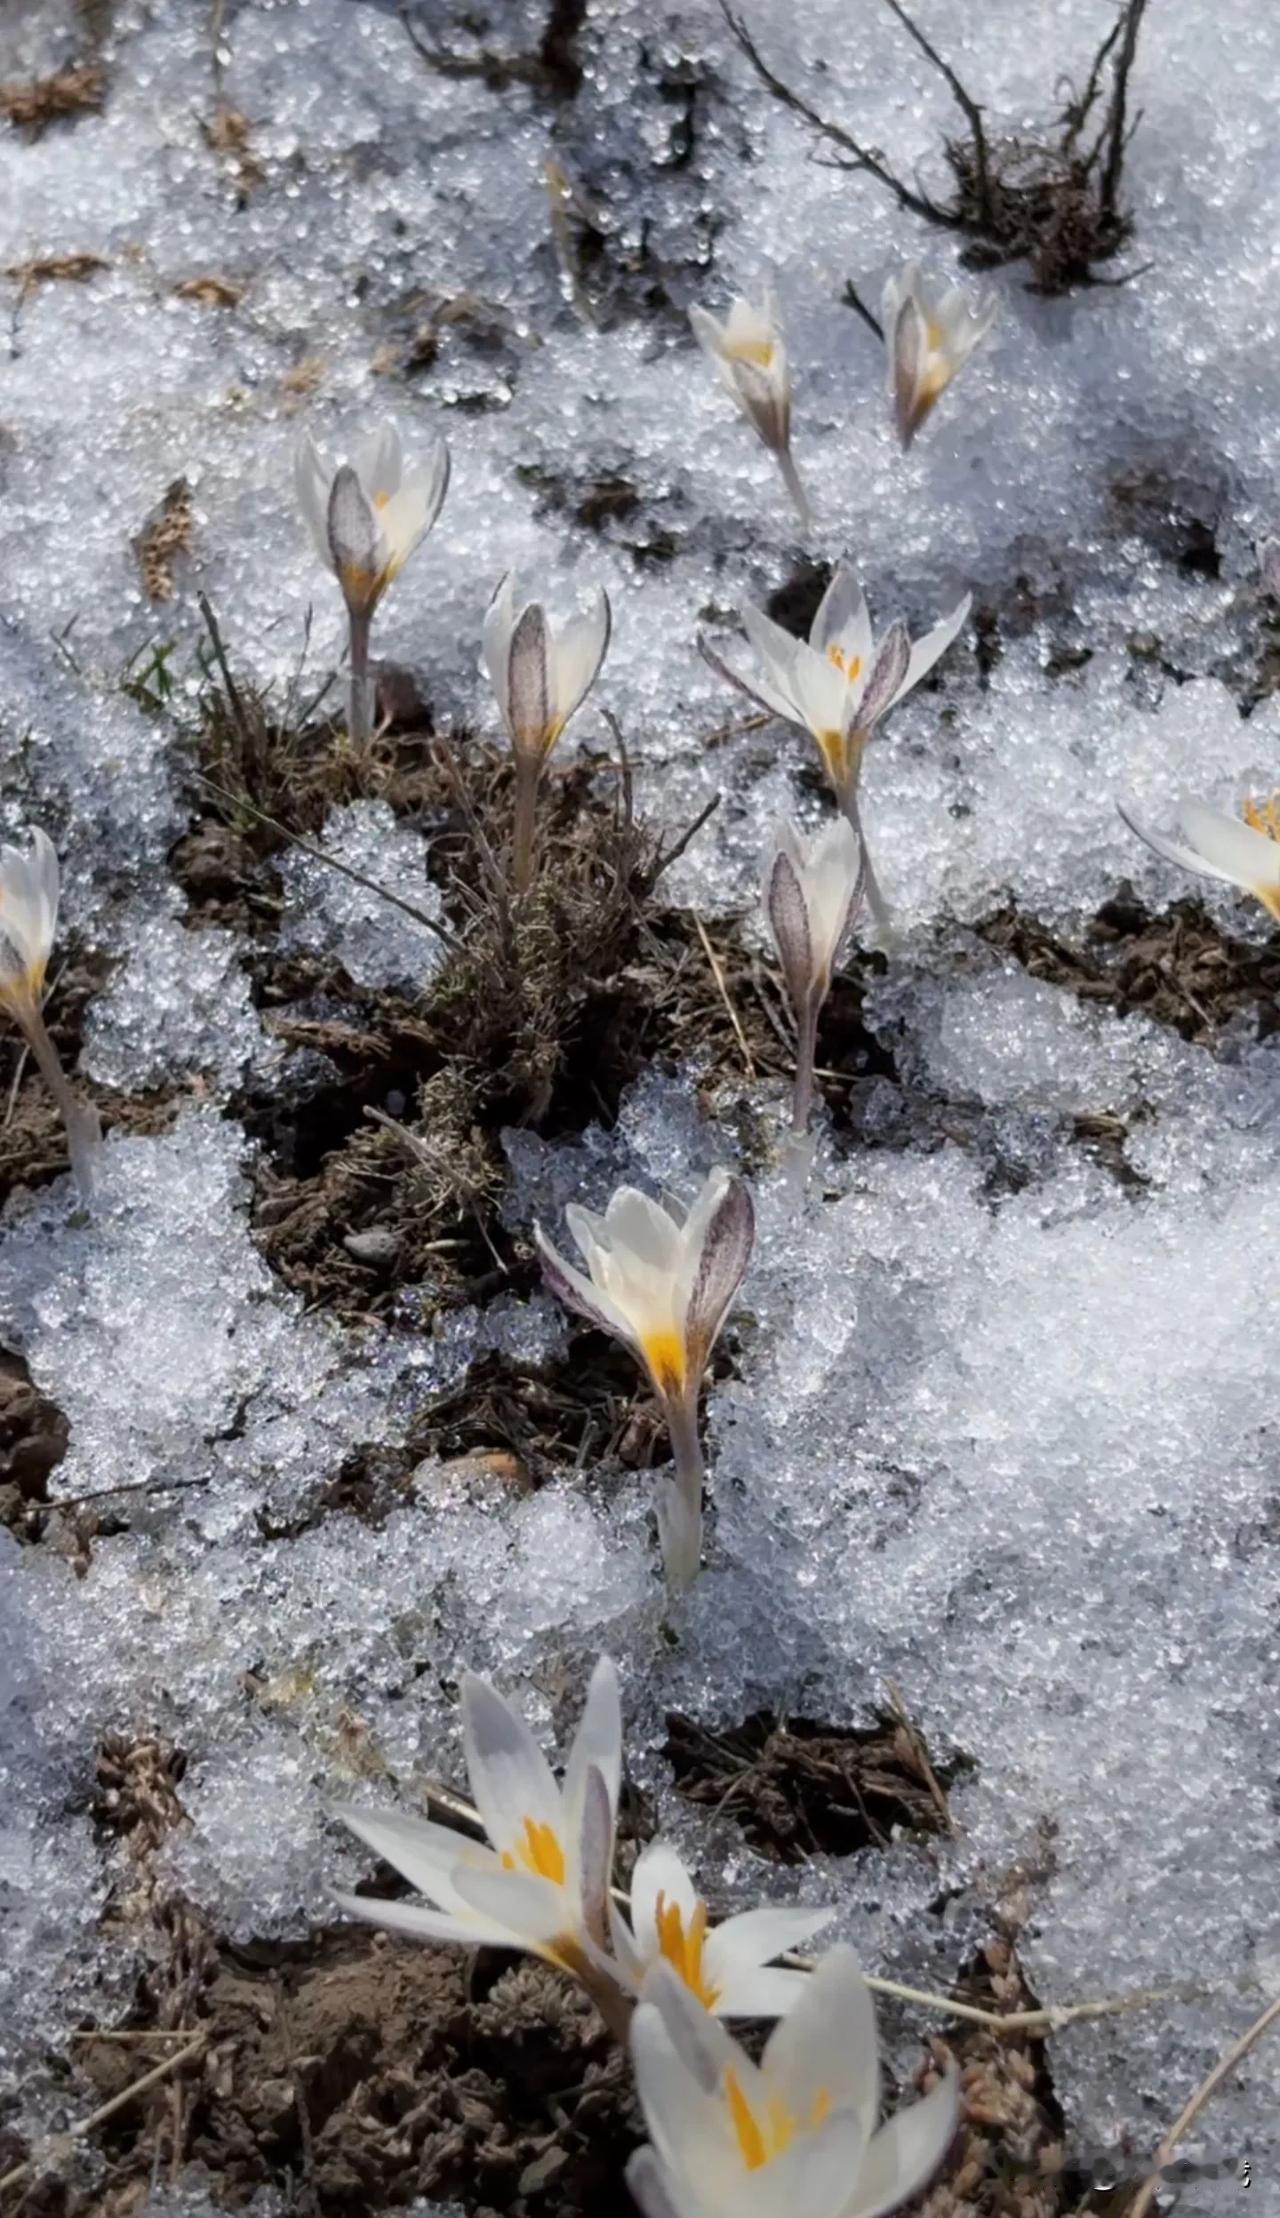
[{"x1": 295, "y1": 424, "x2": 448, "y2": 739}]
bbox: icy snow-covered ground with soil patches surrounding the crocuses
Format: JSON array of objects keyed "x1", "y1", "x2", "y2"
[{"x1": 0, "y1": 0, "x2": 1280, "y2": 2218}]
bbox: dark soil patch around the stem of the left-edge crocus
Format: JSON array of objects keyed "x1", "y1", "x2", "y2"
[{"x1": 0, "y1": 947, "x2": 182, "y2": 1207}]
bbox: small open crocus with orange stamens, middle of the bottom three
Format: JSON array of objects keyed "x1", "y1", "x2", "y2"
[{"x1": 610, "y1": 1841, "x2": 834, "y2": 2018}]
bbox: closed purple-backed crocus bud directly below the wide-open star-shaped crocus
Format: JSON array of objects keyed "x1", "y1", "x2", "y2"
[{"x1": 765, "y1": 816, "x2": 863, "y2": 1133}]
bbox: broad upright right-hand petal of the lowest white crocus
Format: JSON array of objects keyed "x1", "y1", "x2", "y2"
[{"x1": 761, "y1": 1945, "x2": 881, "y2": 2136}]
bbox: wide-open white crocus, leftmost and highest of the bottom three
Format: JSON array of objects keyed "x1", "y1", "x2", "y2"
[{"x1": 335, "y1": 1657, "x2": 628, "y2": 2032}]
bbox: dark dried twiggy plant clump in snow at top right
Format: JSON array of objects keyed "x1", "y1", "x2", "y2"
[{"x1": 721, "y1": 0, "x2": 1147, "y2": 295}]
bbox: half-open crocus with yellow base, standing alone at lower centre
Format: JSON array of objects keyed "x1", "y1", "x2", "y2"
[{"x1": 535, "y1": 1171, "x2": 754, "y2": 1590}]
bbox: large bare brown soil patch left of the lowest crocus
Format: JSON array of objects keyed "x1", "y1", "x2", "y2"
[{"x1": 73, "y1": 1927, "x2": 641, "y2": 2218}]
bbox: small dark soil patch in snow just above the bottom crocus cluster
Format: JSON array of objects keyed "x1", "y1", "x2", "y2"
[{"x1": 666, "y1": 1710, "x2": 961, "y2": 1863}]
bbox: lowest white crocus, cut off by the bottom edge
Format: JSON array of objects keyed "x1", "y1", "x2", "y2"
[{"x1": 628, "y1": 1947, "x2": 958, "y2": 2218}]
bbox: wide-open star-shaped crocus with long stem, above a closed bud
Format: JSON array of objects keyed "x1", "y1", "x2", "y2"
[{"x1": 703, "y1": 563, "x2": 972, "y2": 932}]
